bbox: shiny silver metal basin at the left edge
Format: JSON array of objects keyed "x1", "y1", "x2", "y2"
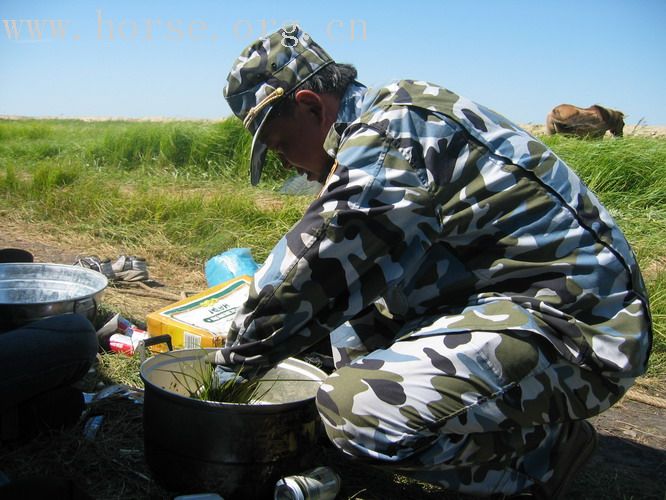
[{"x1": 0, "y1": 263, "x2": 108, "y2": 331}]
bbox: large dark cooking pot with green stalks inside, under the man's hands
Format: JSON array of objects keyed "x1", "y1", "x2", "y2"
[{"x1": 141, "y1": 349, "x2": 326, "y2": 499}]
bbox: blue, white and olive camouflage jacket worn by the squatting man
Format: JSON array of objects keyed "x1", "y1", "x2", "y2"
[{"x1": 223, "y1": 81, "x2": 651, "y2": 377}]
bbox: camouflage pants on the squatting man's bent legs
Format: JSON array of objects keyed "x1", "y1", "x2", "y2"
[{"x1": 317, "y1": 328, "x2": 633, "y2": 495}]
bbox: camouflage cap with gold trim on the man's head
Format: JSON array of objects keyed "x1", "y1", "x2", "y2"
[{"x1": 224, "y1": 25, "x2": 334, "y2": 185}]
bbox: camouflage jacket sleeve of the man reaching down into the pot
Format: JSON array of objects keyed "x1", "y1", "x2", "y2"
[{"x1": 215, "y1": 120, "x2": 438, "y2": 366}]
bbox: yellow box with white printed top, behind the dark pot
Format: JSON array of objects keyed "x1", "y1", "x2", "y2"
[{"x1": 146, "y1": 275, "x2": 252, "y2": 349}]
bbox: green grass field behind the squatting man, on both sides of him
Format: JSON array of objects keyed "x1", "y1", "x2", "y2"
[{"x1": 0, "y1": 120, "x2": 666, "y2": 377}]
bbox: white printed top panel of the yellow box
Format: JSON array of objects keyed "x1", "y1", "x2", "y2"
[{"x1": 160, "y1": 281, "x2": 249, "y2": 335}]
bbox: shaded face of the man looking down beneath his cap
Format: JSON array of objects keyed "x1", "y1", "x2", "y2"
[{"x1": 260, "y1": 91, "x2": 334, "y2": 182}]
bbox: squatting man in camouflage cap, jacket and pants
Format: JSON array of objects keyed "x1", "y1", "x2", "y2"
[{"x1": 209, "y1": 26, "x2": 651, "y2": 498}]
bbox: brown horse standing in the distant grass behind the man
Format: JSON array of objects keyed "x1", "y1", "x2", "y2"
[{"x1": 546, "y1": 104, "x2": 624, "y2": 137}]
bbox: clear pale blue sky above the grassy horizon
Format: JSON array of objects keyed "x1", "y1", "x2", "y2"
[{"x1": 0, "y1": 0, "x2": 666, "y2": 125}]
